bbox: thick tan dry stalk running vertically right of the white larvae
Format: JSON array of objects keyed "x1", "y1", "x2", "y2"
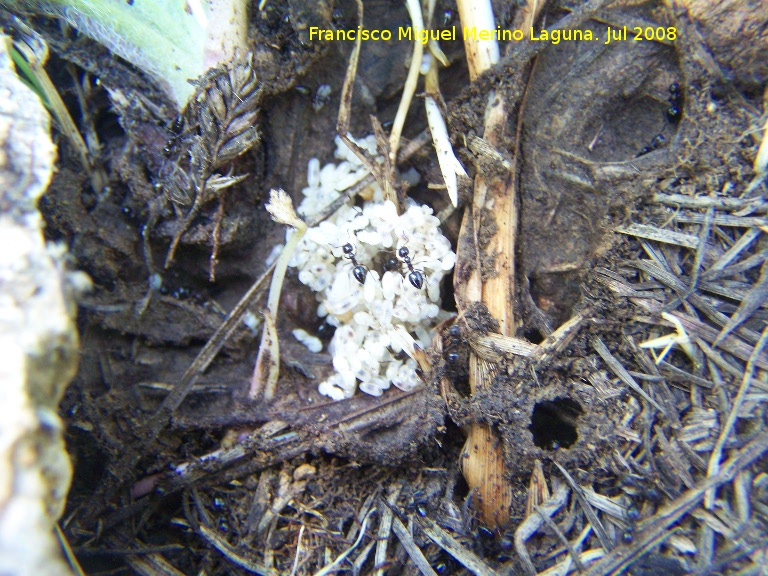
[{"x1": 454, "y1": 1, "x2": 518, "y2": 527}]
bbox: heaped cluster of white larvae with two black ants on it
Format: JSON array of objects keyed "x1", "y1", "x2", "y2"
[{"x1": 288, "y1": 136, "x2": 456, "y2": 400}]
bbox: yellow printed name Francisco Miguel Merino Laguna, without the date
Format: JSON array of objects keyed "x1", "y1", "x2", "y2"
[{"x1": 309, "y1": 26, "x2": 595, "y2": 44}]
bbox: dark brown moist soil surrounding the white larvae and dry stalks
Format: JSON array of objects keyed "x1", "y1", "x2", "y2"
[{"x1": 10, "y1": 0, "x2": 768, "y2": 574}]
